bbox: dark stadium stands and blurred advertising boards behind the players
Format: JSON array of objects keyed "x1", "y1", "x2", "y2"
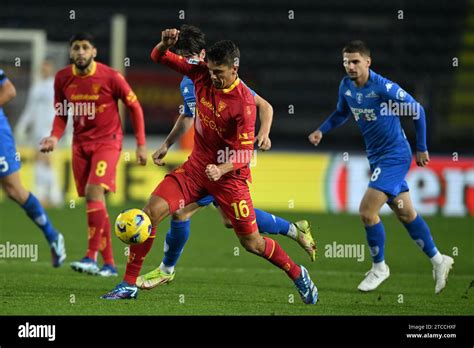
[{"x1": 0, "y1": 0, "x2": 474, "y2": 215}]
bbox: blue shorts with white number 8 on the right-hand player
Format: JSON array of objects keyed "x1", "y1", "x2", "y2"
[{"x1": 369, "y1": 152, "x2": 412, "y2": 203}]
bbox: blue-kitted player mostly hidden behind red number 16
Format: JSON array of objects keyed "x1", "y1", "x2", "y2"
[{"x1": 136, "y1": 24, "x2": 316, "y2": 289}]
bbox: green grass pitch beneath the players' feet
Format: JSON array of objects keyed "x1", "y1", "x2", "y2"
[{"x1": 0, "y1": 202, "x2": 474, "y2": 315}]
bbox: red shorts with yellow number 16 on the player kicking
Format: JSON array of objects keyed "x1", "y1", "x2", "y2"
[{"x1": 152, "y1": 162, "x2": 258, "y2": 234}]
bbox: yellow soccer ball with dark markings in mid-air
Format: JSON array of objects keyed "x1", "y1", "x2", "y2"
[{"x1": 115, "y1": 209, "x2": 151, "y2": 244}]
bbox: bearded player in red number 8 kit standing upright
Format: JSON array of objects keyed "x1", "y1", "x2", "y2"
[{"x1": 41, "y1": 33, "x2": 146, "y2": 277}]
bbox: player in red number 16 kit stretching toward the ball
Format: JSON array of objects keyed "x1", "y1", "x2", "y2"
[{"x1": 102, "y1": 29, "x2": 318, "y2": 304}]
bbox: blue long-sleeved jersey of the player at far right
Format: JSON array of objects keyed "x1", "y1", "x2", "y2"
[{"x1": 319, "y1": 70, "x2": 427, "y2": 163}]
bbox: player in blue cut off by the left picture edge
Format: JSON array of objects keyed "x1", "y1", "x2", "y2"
[{"x1": 0, "y1": 69, "x2": 66, "y2": 267}]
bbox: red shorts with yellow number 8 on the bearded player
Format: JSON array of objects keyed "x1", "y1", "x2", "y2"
[{"x1": 72, "y1": 143, "x2": 121, "y2": 197}]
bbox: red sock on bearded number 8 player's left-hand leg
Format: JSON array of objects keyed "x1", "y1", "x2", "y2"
[{"x1": 86, "y1": 201, "x2": 107, "y2": 261}]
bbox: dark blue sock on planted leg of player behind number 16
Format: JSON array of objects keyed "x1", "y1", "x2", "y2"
[{"x1": 162, "y1": 220, "x2": 191, "y2": 267}]
